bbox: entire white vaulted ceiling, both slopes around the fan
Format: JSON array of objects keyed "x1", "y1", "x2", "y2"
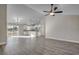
[{"x1": 7, "y1": 4, "x2": 79, "y2": 23}]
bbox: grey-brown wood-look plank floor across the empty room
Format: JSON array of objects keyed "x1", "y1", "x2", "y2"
[{"x1": 0, "y1": 37, "x2": 79, "y2": 55}]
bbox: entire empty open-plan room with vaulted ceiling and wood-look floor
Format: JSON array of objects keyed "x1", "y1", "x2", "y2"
[{"x1": 0, "y1": 4, "x2": 79, "y2": 55}]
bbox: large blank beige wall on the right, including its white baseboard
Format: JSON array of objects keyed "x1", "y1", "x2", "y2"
[{"x1": 45, "y1": 15, "x2": 79, "y2": 43}]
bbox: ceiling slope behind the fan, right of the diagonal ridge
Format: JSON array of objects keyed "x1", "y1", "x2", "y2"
[{"x1": 27, "y1": 4, "x2": 79, "y2": 15}]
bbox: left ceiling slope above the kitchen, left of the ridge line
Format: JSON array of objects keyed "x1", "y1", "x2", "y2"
[{"x1": 7, "y1": 4, "x2": 43, "y2": 24}]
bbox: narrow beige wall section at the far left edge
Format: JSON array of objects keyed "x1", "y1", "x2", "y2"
[{"x1": 0, "y1": 4, "x2": 7, "y2": 45}]
